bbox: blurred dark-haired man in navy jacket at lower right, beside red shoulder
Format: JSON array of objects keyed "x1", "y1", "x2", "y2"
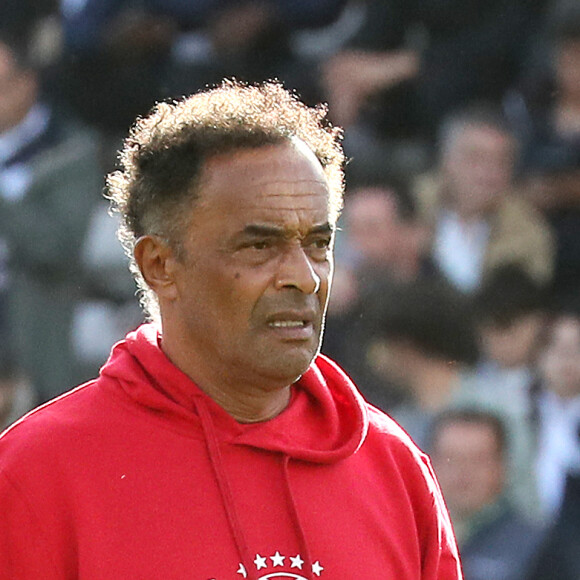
[{"x1": 429, "y1": 408, "x2": 548, "y2": 580}]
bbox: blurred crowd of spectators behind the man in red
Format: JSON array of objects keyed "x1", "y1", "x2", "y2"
[{"x1": 0, "y1": 0, "x2": 580, "y2": 580}]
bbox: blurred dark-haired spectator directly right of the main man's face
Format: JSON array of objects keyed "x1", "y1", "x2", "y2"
[{"x1": 323, "y1": 176, "x2": 433, "y2": 410}]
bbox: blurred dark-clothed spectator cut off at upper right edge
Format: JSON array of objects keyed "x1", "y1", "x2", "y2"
[{"x1": 509, "y1": 0, "x2": 580, "y2": 305}]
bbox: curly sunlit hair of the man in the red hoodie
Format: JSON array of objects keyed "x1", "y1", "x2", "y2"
[{"x1": 106, "y1": 80, "x2": 344, "y2": 319}]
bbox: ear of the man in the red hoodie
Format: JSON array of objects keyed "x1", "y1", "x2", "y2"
[{"x1": 134, "y1": 235, "x2": 177, "y2": 300}]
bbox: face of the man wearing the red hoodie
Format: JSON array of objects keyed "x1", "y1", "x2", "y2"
[{"x1": 162, "y1": 143, "x2": 334, "y2": 386}]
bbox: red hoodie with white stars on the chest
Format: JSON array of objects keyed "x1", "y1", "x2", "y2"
[{"x1": 0, "y1": 325, "x2": 461, "y2": 580}]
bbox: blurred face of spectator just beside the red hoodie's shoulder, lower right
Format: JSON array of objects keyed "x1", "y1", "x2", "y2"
[{"x1": 431, "y1": 421, "x2": 504, "y2": 517}]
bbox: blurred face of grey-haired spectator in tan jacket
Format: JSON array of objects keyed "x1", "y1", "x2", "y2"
[{"x1": 443, "y1": 126, "x2": 514, "y2": 217}]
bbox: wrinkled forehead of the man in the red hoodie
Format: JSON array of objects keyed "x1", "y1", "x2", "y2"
[{"x1": 198, "y1": 143, "x2": 331, "y2": 227}]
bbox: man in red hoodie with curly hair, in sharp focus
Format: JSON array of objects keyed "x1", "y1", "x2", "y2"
[{"x1": 0, "y1": 82, "x2": 461, "y2": 580}]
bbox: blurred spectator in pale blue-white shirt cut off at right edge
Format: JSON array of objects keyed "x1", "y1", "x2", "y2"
[{"x1": 535, "y1": 311, "x2": 580, "y2": 517}]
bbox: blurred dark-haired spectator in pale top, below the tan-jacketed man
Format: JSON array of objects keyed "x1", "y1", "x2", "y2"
[{"x1": 461, "y1": 265, "x2": 548, "y2": 519}]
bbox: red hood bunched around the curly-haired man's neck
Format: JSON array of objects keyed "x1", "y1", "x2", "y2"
[{"x1": 100, "y1": 324, "x2": 368, "y2": 463}]
